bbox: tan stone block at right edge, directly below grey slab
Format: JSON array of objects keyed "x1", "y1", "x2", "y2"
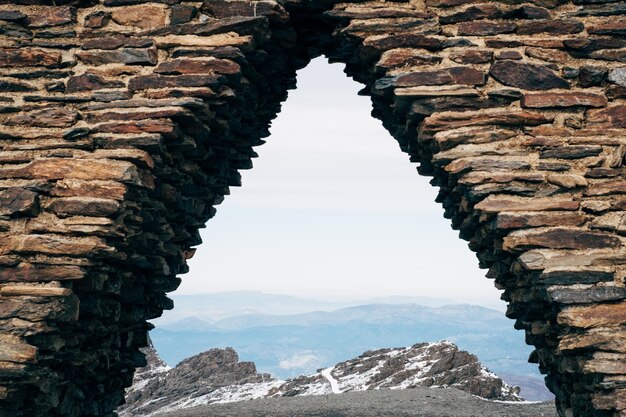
[{"x1": 557, "y1": 301, "x2": 626, "y2": 329}]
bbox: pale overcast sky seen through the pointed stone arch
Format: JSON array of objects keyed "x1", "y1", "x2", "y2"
[{"x1": 177, "y1": 59, "x2": 504, "y2": 309}]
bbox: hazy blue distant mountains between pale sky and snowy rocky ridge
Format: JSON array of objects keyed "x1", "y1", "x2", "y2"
[{"x1": 151, "y1": 292, "x2": 551, "y2": 400}]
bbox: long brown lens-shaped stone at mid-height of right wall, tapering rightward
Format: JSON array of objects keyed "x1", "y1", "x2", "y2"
[{"x1": 502, "y1": 228, "x2": 622, "y2": 251}]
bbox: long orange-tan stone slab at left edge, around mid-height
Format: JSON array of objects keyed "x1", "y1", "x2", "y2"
[{"x1": 0, "y1": 158, "x2": 142, "y2": 185}]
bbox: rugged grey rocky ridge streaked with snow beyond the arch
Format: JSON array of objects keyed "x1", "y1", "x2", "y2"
[{"x1": 118, "y1": 342, "x2": 521, "y2": 417}]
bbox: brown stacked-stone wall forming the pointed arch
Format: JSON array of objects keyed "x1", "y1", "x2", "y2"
[{"x1": 0, "y1": 0, "x2": 626, "y2": 417}]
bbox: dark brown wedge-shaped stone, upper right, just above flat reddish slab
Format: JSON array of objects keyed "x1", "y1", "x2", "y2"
[{"x1": 489, "y1": 61, "x2": 569, "y2": 90}]
